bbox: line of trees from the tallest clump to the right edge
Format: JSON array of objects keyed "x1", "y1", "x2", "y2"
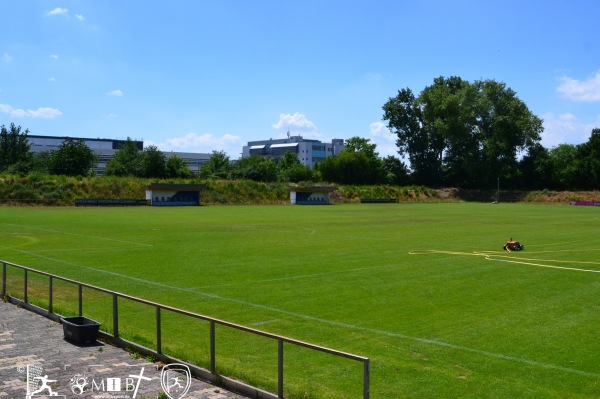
[{"x1": 383, "y1": 77, "x2": 600, "y2": 190}]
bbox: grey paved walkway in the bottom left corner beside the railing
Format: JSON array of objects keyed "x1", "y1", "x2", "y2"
[{"x1": 0, "y1": 301, "x2": 246, "y2": 399}]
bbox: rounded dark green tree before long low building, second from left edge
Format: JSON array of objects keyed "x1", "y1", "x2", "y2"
[{"x1": 49, "y1": 138, "x2": 96, "y2": 176}]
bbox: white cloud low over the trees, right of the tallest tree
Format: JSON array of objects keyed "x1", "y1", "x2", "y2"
[{"x1": 542, "y1": 113, "x2": 600, "y2": 149}]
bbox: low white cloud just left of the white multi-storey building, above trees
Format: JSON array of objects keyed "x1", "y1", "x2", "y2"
[{"x1": 149, "y1": 133, "x2": 245, "y2": 159}]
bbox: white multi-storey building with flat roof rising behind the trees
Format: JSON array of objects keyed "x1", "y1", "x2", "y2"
[{"x1": 242, "y1": 133, "x2": 344, "y2": 168}]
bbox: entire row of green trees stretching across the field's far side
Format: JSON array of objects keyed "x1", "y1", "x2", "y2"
[{"x1": 0, "y1": 77, "x2": 600, "y2": 190}]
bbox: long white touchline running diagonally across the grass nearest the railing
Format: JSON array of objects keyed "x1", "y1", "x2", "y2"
[{"x1": 16, "y1": 250, "x2": 600, "y2": 379}]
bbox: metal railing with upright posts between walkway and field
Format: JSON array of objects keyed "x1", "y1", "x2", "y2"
[{"x1": 0, "y1": 260, "x2": 370, "y2": 399}]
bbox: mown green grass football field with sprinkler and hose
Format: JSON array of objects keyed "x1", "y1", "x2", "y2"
[{"x1": 0, "y1": 203, "x2": 600, "y2": 399}]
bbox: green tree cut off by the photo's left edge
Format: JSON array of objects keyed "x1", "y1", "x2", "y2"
[{"x1": 0, "y1": 123, "x2": 33, "y2": 173}]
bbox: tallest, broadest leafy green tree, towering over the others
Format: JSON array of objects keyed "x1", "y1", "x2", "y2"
[{"x1": 383, "y1": 77, "x2": 542, "y2": 187}]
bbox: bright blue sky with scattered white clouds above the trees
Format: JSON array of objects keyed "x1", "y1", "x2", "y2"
[{"x1": 0, "y1": 0, "x2": 600, "y2": 159}]
